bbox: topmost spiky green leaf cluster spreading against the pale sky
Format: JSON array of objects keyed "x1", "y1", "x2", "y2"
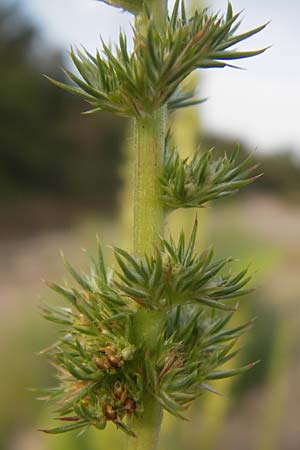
[{"x1": 52, "y1": 0, "x2": 265, "y2": 117}]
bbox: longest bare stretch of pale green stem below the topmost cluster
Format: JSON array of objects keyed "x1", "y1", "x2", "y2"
[{"x1": 133, "y1": 107, "x2": 166, "y2": 256}]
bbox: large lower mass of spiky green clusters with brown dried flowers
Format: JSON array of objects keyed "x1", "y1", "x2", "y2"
[{"x1": 43, "y1": 229, "x2": 253, "y2": 434}]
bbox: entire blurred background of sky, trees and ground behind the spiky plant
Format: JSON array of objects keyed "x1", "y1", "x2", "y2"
[{"x1": 0, "y1": 0, "x2": 300, "y2": 450}]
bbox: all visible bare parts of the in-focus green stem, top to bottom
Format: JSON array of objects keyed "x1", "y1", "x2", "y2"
[{"x1": 127, "y1": 0, "x2": 168, "y2": 450}]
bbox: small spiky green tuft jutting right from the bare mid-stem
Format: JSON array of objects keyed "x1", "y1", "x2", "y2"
[{"x1": 161, "y1": 140, "x2": 260, "y2": 211}]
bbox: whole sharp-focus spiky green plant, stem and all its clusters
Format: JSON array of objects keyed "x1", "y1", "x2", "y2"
[{"x1": 39, "y1": 0, "x2": 265, "y2": 450}]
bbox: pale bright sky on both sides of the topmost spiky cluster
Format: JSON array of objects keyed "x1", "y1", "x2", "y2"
[{"x1": 9, "y1": 0, "x2": 300, "y2": 155}]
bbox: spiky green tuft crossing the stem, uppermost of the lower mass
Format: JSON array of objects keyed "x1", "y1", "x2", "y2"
[{"x1": 115, "y1": 221, "x2": 251, "y2": 311}]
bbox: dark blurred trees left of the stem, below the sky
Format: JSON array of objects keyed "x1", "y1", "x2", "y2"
[{"x1": 0, "y1": 6, "x2": 125, "y2": 225}]
